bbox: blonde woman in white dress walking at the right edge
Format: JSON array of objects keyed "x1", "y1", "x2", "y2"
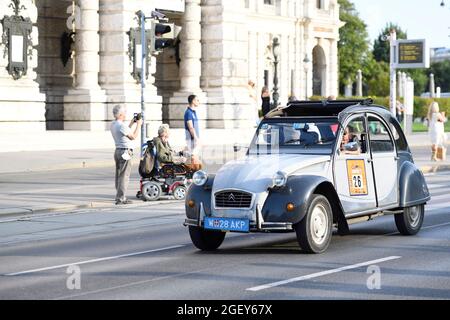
[{"x1": 427, "y1": 102, "x2": 447, "y2": 161}]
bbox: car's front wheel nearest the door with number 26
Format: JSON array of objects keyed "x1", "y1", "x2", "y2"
[{"x1": 294, "y1": 194, "x2": 333, "y2": 253}]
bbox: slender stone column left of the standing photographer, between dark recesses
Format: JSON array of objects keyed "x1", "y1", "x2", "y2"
[{"x1": 64, "y1": 0, "x2": 107, "y2": 131}]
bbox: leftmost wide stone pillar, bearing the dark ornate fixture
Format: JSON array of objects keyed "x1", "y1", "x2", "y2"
[{"x1": 0, "y1": 0, "x2": 46, "y2": 134}]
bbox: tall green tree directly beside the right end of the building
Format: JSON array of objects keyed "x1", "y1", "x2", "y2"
[{"x1": 338, "y1": 0, "x2": 370, "y2": 87}]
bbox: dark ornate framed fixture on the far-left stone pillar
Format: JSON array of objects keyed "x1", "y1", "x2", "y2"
[{"x1": 2, "y1": 0, "x2": 33, "y2": 80}]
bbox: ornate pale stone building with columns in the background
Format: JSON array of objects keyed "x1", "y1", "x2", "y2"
[{"x1": 0, "y1": 0, "x2": 341, "y2": 135}]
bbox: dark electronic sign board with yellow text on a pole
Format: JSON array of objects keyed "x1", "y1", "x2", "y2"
[{"x1": 395, "y1": 39, "x2": 430, "y2": 69}]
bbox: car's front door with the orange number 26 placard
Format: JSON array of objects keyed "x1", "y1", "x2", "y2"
[{"x1": 334, "y1": 114, "x2": 377, "y2": 215}]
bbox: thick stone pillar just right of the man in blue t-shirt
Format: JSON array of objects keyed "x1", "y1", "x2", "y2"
[{"x1": 202, "y1": 0, "x2": 255, "y2": 128}]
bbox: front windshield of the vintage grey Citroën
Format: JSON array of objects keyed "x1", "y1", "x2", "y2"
[{"x1": 249, "y1": 118, "x2": 339, "y2": 154}]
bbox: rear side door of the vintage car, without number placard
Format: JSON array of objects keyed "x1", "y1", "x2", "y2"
[{"x1": 367, "y1": 113, "x2": 398, "y2": 208}]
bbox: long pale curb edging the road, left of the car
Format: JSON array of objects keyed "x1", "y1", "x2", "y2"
[{"x1": 0, "y1": 199, "x2": 181, "y2": 219}]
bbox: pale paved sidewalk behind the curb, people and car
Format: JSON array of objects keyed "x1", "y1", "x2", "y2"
[{"x1": 0, "y1": 133, "x2": 450, "y2": 218}]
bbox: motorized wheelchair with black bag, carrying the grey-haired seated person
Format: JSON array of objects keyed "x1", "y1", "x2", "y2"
[{"x1": 136, "y1": 140, "x2": 195, "y2": 201}]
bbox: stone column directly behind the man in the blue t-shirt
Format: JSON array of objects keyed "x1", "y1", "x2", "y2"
[{"x1": 167, "y1": 0, "x2": 207, "y2": 128}]
